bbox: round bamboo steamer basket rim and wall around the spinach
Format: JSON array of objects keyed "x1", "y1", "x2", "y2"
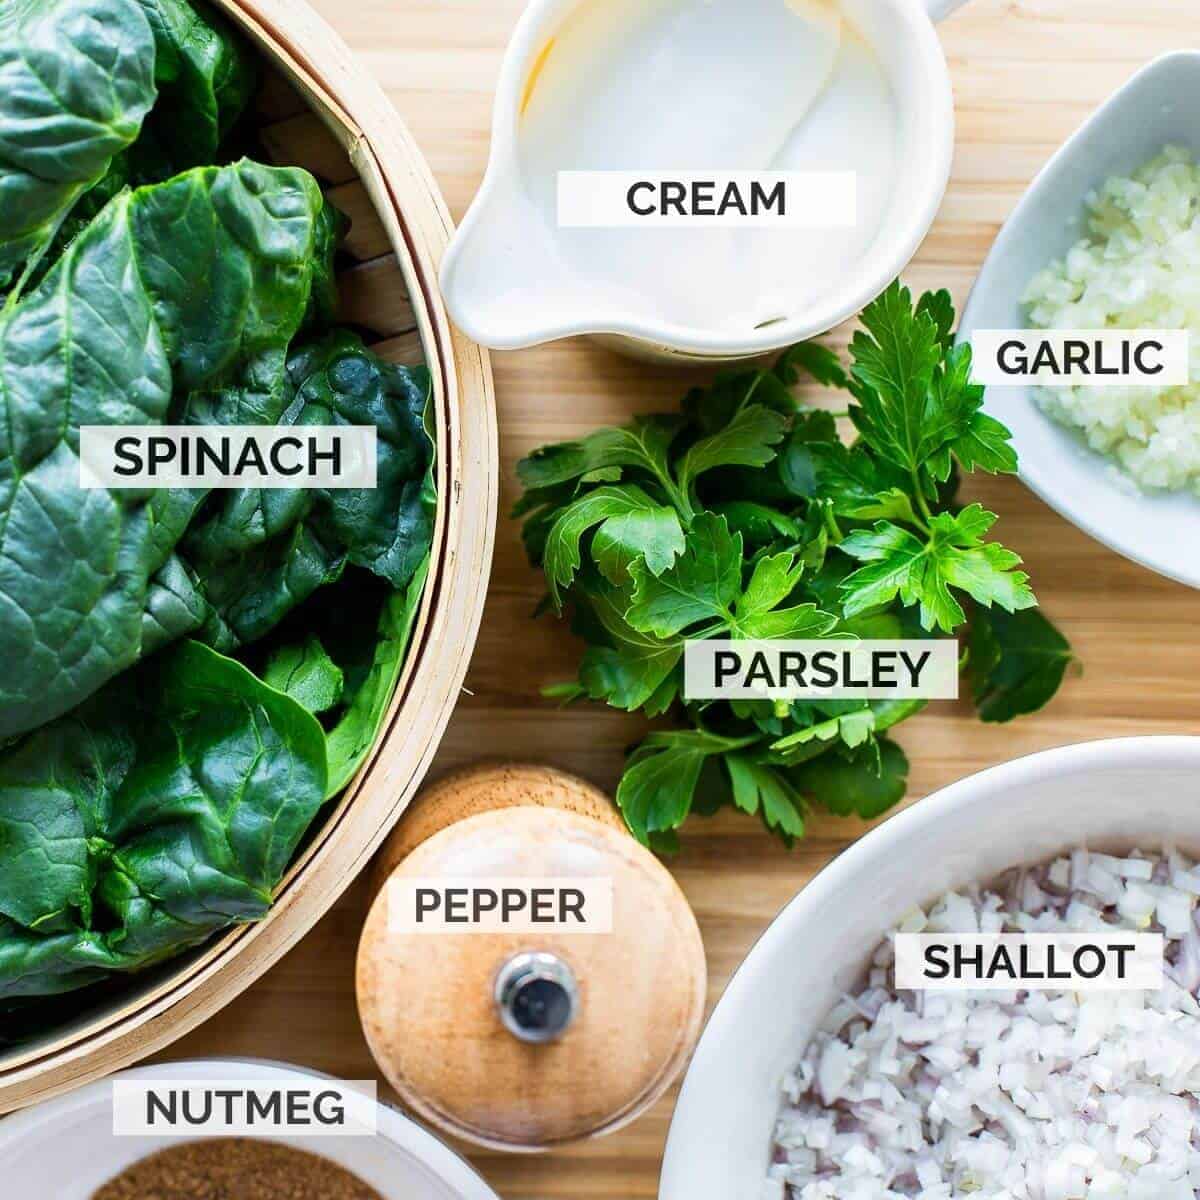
[{"x1": 0, "y1": 0, "x2": 498, "y2": 1112}]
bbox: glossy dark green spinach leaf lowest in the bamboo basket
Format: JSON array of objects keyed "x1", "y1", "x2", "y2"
[{"x1": 0, "y1": 642, "x2": 328, "y2": 1000}]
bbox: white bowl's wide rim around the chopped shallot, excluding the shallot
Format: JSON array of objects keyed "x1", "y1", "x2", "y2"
[{"x1": 659, "y1": 737, "x2": 1200, "y2": 1200}]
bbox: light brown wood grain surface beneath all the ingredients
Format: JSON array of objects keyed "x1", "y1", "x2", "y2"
[{"x1": 170, "y1": 0, "x2": 1200, "y2": 1200}]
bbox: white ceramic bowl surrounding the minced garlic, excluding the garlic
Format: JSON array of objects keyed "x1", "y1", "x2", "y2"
[{"x1": 959, "y1": 50, "x2": 1200, "y2": 587}]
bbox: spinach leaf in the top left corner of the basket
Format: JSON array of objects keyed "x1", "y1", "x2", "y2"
[{"x1": 0, "y1": 0, "x2": 258, "y2": 293}]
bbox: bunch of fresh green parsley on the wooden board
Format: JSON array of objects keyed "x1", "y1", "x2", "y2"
[{"x1": 514, "y1": 283, "x2": 1070, "y2": 848}]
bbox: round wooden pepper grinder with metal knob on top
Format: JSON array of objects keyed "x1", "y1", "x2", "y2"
[{"x1": 358, "y1": 764, "x2": 707, "y2": 1151}]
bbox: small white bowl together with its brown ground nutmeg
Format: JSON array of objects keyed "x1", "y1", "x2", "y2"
[{"x1": 0, "y1": 1058, "x2": 497, "y2": 1200}]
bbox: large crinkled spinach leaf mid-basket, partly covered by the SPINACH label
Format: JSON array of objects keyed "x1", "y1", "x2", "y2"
[{"x1": 0, "y1": 162, "x2": 322, "y2": 738}]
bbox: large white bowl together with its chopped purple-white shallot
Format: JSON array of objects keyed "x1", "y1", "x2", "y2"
[{"x1": 659, "y1": 737, "x2": 1200, "y2": 1200}]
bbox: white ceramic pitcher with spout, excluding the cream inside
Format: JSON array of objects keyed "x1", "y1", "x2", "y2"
[{"x1": 442, "y1": 0, "x2": 965, "y2": 362}]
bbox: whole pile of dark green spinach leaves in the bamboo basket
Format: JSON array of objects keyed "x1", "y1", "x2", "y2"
[{"x1": 0, "y1": 0, "x2": 436, "y2": 1022}]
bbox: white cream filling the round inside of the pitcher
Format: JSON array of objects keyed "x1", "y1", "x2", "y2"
[{"x1": 517, "y1": 0, "x2": 895, "y2": 329}]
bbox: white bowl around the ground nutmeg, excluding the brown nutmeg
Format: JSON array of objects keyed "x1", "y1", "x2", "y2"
[{"x1": 0, "y1": 1058, "x2": 498, "y2": 1200}]
